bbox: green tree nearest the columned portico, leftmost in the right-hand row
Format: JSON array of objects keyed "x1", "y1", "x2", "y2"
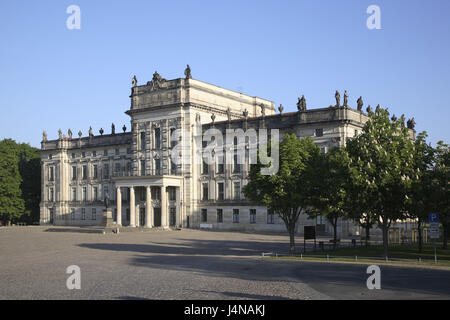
[{"x1": 243, "y1": 134, "x2": 320, "y2": 254}]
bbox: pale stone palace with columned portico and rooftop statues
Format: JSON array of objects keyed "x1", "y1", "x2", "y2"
[{"x1": 40, "y1": 66, "x2": 368, "y2": 234}]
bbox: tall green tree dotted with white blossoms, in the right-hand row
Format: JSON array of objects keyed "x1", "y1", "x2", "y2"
[{"x1": 347, "y1": 107, "x2": 413, "y2": 257}]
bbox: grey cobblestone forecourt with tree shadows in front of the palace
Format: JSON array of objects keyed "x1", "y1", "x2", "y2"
[{"x1": 0, "y1": 227, "x2": 450, "y2": 300}]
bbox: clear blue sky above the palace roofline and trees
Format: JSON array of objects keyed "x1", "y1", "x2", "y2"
[{"x1": 0, "y1": 0, "x2": 450, "y2": 147}]
